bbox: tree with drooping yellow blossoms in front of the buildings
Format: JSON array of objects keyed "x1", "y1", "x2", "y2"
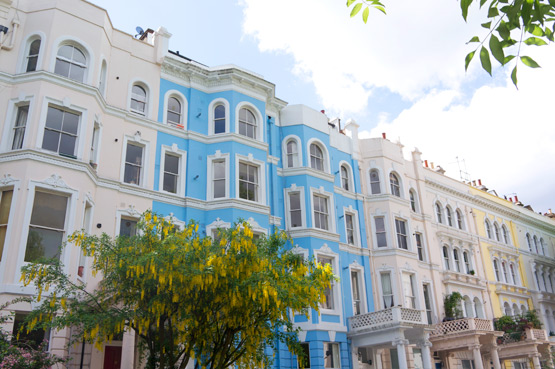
[{"x1": 22, "y1": 212, "x2": 332, "y2": 369}]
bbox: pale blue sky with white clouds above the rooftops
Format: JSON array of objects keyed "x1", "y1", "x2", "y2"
[{"x1": 88, "y1": 0, "x2": 555, "y2": 213}]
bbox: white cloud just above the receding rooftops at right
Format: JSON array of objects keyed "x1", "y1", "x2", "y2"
[{"x1": 363, "y1": 48, "x2": 555, "y2": 212}]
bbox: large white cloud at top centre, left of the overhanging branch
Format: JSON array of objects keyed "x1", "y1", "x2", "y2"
[{"x1": 242, "y1": 0, "x2": 484, "y2": 114}]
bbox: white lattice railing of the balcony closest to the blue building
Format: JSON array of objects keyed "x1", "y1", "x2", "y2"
[{"x1": 349, "y1": 306, "x2": 428, "y2": 332}]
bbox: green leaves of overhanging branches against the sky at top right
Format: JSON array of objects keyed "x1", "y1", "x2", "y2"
[{"x1": 347, "y1": 0, "x2": 555, "y2": 86}]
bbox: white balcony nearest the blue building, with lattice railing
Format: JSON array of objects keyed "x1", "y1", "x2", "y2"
[{"x1": 348, "y1": 306, "x2": 429, "y2": 347}]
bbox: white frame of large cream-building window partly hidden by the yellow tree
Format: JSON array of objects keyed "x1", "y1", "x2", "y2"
[{"x1": 15, "y1": 178, "x2": 79, "y2": 278}]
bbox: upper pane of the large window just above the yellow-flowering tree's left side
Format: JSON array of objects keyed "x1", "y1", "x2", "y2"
[{"x1": 31, "y1": 192, "x2": 67, "y2": 230}]
